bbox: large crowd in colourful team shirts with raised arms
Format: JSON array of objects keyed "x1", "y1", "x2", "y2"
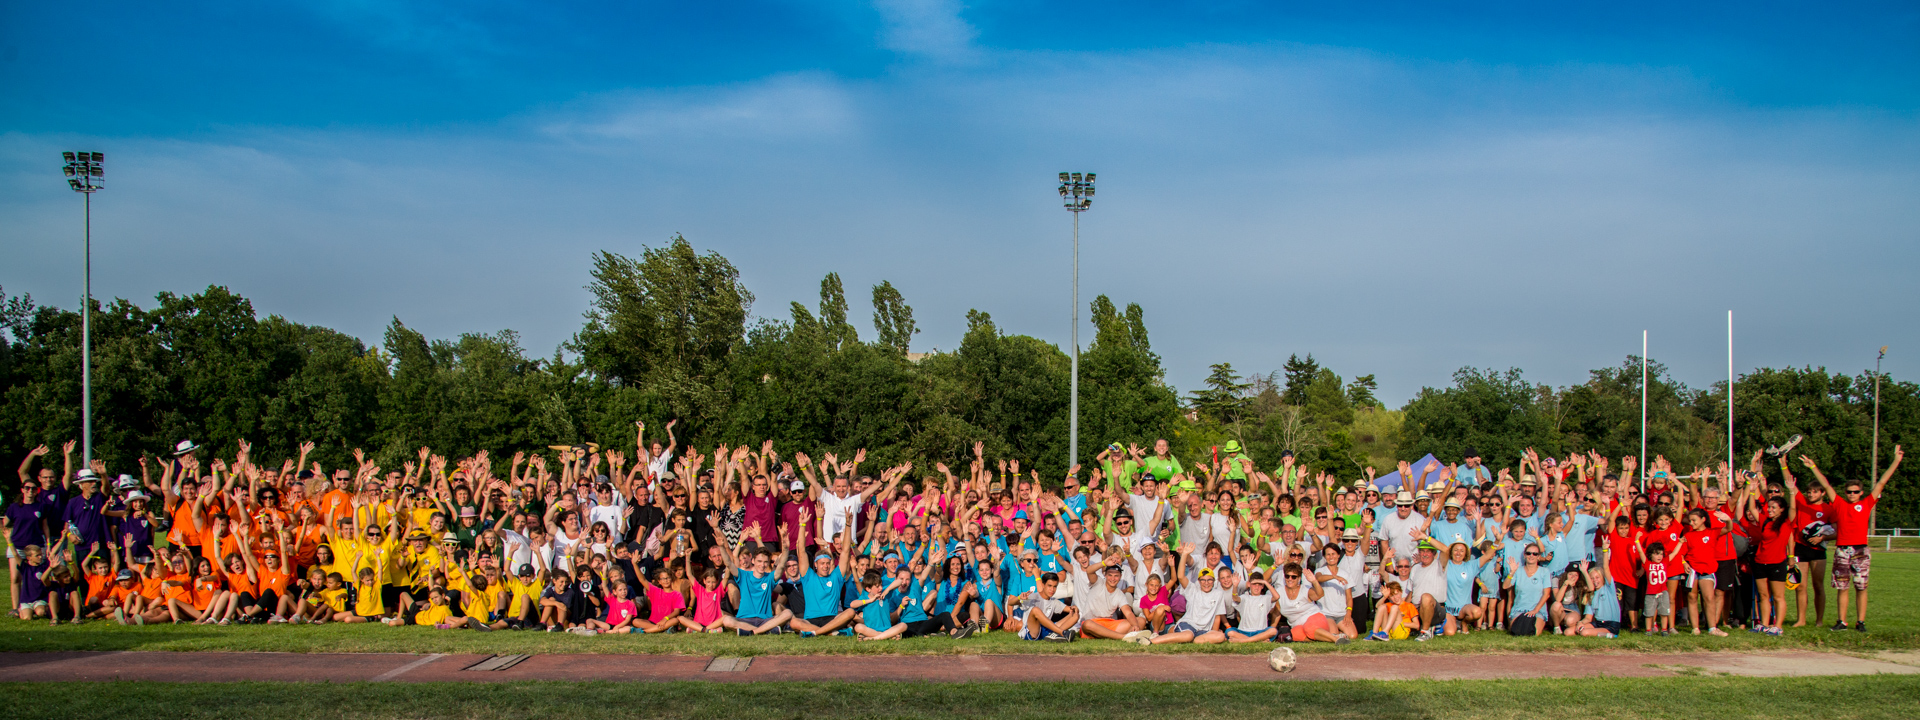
[{"x1": 4, "y1": 422, "x2": 1903, "y2": 645}]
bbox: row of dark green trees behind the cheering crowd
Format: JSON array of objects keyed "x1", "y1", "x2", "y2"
[{"x1": 0, "y1": 236, "x2": 1920, "y2": 526}]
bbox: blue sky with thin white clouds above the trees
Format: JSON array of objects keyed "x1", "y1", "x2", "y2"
[{"x1": 0, "y1": 0, "x2": 1920, "y2": 403}]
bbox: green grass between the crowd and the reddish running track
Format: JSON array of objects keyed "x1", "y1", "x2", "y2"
[{"x1": 0, "y1": 553, "x2": 1920, "y2": 655}]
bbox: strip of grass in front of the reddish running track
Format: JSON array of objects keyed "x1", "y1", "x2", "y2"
[{"x1": 0, "y1": 676, "x2": 1920, "y2": 720}]
